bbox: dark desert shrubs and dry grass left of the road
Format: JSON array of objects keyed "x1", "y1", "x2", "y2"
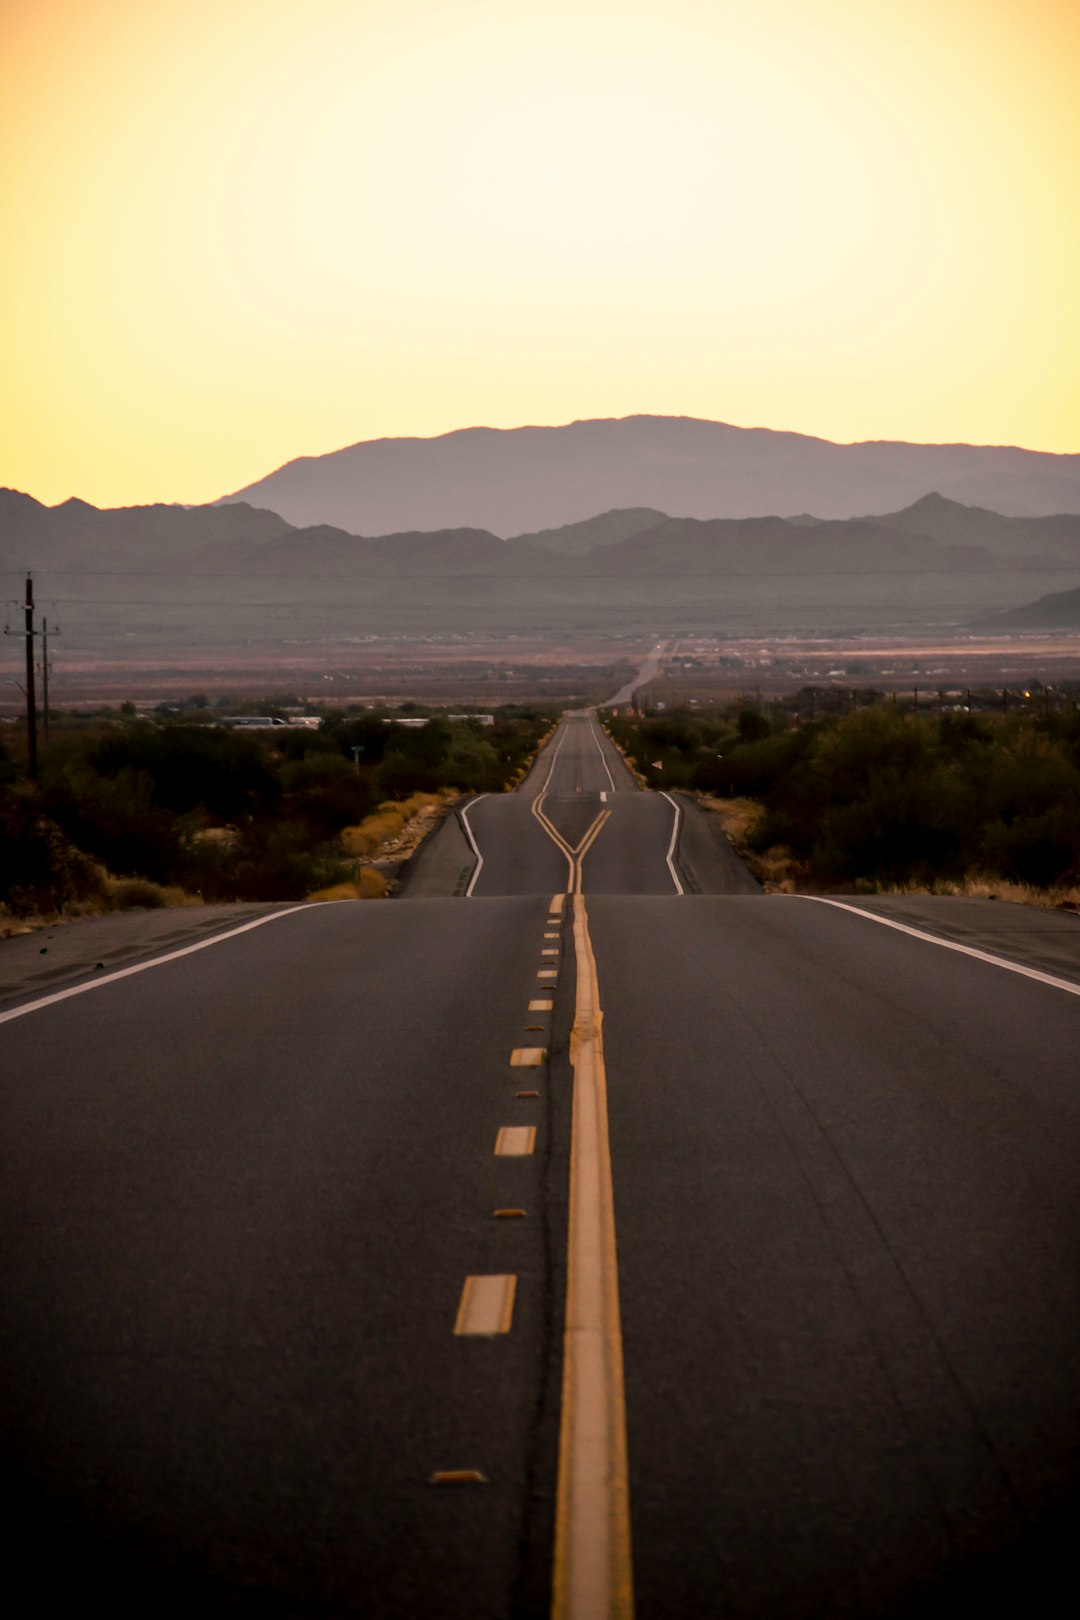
[{"x1": 0, "y1": 701, "x2": 554, "y2": 919}]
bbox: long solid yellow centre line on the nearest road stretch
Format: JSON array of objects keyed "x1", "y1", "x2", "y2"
[{"x1": 552, "y1": 893, "x2": 633, "y2": 1620}]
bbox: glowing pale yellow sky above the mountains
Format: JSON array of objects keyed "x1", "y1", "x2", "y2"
[{"x1": 0, "y1": 0, "x2": 1080, "y2": 505}]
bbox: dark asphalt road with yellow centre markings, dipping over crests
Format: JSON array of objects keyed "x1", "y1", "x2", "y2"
[{"x1": 0, "y1": 716, "x2": 1080, "y2": 1620}]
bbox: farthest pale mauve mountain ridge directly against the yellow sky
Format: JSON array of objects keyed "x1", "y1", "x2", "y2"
[{"x1": 215, "y1": 416, "x2": 1080, "y2": 536}]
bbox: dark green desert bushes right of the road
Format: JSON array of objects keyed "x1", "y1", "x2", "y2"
[{"x1": 609, "y1": 703, "x2": 1080, "y2": 889}]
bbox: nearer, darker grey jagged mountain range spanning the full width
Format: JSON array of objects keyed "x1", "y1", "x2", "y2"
[{"x1": 0, "y1": 491, "x2": 1080, "y2": 651}]
